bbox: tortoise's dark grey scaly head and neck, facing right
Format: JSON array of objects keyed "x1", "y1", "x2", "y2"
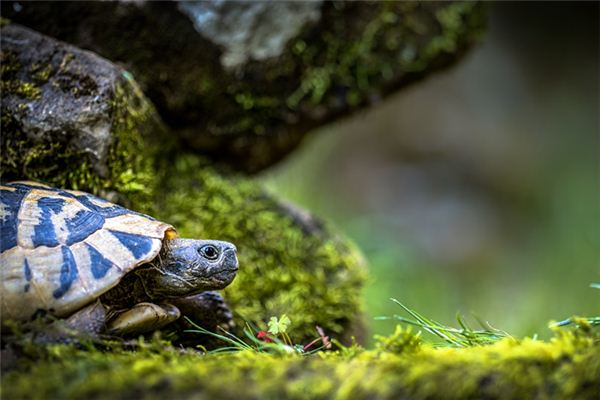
[{"x1": 136, "y1": 239, "x2": 238, "y2": 299}]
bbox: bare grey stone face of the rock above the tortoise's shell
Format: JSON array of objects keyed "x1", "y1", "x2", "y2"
[{"x1": 1, "y1": 25, "x2": 121, "y2": 178}]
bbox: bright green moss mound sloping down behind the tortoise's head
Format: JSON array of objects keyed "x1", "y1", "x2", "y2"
[{"x1": 150, "y1": 155, "x2": 365, "y2": 341}]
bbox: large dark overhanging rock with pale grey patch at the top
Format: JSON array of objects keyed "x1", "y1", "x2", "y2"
[{"x1": 2, "y1": 1, "x2": 483, "y2": 172}]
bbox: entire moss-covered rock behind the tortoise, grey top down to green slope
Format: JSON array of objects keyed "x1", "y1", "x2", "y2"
[{"x1": 0, "y1": 24, "x2": 365, "y2": 341}]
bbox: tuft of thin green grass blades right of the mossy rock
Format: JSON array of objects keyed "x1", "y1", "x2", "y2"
[{"x1": 376, "y1": 298, "x2": 511, "y2": 347}]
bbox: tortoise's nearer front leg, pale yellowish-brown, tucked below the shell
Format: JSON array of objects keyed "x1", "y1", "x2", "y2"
[{"x1": 107, "y1": 303, "x2": 181, "y2": 336}]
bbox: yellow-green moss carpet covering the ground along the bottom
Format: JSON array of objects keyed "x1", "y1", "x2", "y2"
[{"x1": 2, "y1": 332, "x2": 600, "y2": 400}]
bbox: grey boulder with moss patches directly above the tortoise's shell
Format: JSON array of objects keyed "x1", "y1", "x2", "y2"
[{"x1": 0, "y1": 24, "x2": 164, "y2": 209}]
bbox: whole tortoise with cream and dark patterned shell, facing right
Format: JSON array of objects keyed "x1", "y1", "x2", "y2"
[{"x1": 0, "y1": 181, "x2": 238, "y2": 336}]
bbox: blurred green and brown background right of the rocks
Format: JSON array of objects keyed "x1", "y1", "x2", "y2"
[{"x1": 261, "y1": 2, "x2": 600, "y2": 337}]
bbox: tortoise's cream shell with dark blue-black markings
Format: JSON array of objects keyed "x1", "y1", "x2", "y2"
[{"x1": 0, "y1": 182, "x2": 174, "y2": 321}]
